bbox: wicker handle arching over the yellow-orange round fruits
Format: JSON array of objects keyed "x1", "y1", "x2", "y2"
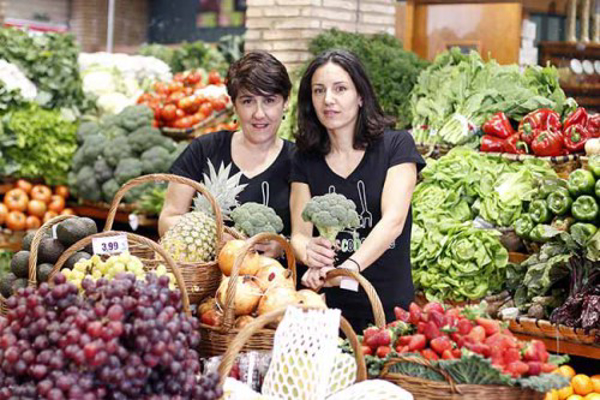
[{"x1": 222, "y1": 232, "x2": 296, "y2": 332}]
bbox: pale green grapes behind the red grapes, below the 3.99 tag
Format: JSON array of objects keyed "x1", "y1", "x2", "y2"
[{"x1": 61, "y1": 252, "x2": 175, "y2": 290}]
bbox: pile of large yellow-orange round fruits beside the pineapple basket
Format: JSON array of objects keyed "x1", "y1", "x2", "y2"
[{"x1": 198, "y1": 240, "x2": 327, "y2": 328}]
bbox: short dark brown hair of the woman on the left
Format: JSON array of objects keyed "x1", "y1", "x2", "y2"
[{"x1": 226, "y1": 51, "x2": 292, "y2": 102}]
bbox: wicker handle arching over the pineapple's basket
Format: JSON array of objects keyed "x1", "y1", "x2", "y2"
[{"x1": 104, "y1": 174, "x2": 223, "y2": 244}]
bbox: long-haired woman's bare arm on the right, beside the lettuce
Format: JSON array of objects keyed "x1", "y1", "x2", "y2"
[{"x1": 321, "y1": 163, "x2": 417, "y2": 282}]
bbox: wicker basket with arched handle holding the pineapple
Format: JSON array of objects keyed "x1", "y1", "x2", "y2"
[{"x1": 104, "y1": 174, "x2": 223, "y2": 304}]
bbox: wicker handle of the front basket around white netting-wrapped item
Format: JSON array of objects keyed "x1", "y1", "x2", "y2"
[{"x1": 218, "y1": 306, "x2": 367, "y2": 385}]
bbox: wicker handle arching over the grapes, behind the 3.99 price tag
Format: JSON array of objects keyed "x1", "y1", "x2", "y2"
[{"x1": 48, "y1": 231, "x2": 191, "y2": 315}]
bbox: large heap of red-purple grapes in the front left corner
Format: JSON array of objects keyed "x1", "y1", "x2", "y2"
[{"x1": 0, "y1": 274, "x2": 223, "y2": 400}]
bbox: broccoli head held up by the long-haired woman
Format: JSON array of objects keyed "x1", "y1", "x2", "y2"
[{"x1": 302, "y1": 193, "x2": 360, "y2": 243}]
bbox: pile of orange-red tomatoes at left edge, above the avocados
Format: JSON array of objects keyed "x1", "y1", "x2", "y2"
[{"x1": 0, "y1": 179, "x2": 74, "y2": 231}]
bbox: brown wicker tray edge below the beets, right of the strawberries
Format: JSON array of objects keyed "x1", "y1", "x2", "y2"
[{"x1": 508, "y1": 317, "x2": 600, "y2": 348}]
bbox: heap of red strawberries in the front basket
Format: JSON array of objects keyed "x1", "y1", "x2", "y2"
[{"x1": 362, "y1": 303, "x2": 557, "y2": 378}]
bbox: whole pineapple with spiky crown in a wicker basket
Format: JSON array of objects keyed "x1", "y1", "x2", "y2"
[{"x1": 161, "y1": 160, "x2": 246, "y2": 263}]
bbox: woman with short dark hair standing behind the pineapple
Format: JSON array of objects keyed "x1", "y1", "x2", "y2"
[{"x1": 159, "y1": 51, "x2": 293, "y2": 256}]
